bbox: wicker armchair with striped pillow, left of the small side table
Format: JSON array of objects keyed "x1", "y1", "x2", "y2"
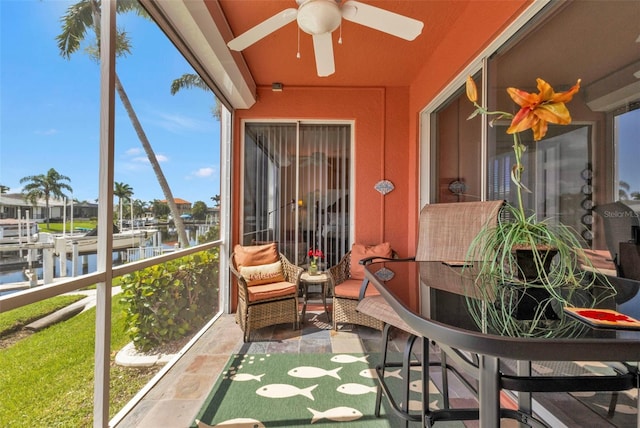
[{"x1": 229, "y1": 243, "x2": 303, "y2": 342}]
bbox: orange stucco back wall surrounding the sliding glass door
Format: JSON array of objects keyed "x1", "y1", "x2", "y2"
[{"x1": 233, "y1": 87, "x2": 414, "y2": 255}]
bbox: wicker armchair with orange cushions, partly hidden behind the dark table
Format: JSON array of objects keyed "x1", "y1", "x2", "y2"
[{"x1": 329, "y1": 243, "x2": 395, "y2": 330}]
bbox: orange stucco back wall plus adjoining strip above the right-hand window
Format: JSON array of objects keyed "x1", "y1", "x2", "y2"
[{"x1": 232, "y1": 0, "x2": 531, "y2": 264}]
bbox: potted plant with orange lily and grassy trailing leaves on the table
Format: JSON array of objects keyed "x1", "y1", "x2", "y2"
[{"x1": 466, "y1": 77, "x2": 615, "y2": 337}]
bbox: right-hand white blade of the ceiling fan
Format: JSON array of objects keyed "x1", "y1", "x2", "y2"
[{"x1": 342, "y1": 0, "x2": 424, "y2": 41}]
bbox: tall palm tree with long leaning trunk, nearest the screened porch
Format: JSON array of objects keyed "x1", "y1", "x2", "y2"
[{"x1": 56, "y1": 0, "x2": 189, "y2": 248}]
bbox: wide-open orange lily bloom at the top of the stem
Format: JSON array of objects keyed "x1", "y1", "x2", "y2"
[{"x1": 507, "y1": 79, "x2": 580, "y2": 141}]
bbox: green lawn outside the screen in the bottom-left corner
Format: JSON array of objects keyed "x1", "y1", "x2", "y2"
[{"x1": 0, "y1": 298, "x2": 159, "y2": 427}]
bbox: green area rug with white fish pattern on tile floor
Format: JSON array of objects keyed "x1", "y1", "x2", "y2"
[{"x1": 192, "y1": 354, "x2": 463, "y2": 428}]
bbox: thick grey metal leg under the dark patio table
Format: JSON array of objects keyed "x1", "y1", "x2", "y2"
[{"x1": 478, "y1": 355, "x2": 500, "y2": 428}]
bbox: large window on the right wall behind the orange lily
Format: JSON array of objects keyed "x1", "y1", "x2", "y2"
[{"x1": 427, "y1": 1, "x2": 640, "y2": 245}]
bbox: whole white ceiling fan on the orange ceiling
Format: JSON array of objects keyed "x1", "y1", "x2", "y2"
[{"x1": 227, "y1": 0, "x2": 424, "y2": 77}]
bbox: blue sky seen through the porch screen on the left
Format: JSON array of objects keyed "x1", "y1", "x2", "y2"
[{"x1": 0, "y1": 0, "x2": 220, "y2": 205}]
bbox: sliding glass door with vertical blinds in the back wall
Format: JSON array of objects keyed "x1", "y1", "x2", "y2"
[{"x1": 243, "y1": 122, "x2": 351, "y2": 266}]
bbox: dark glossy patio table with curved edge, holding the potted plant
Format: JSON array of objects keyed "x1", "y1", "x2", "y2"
[{"x1": 365, "y1": 260, "x2": 640, "y2": 428}]
